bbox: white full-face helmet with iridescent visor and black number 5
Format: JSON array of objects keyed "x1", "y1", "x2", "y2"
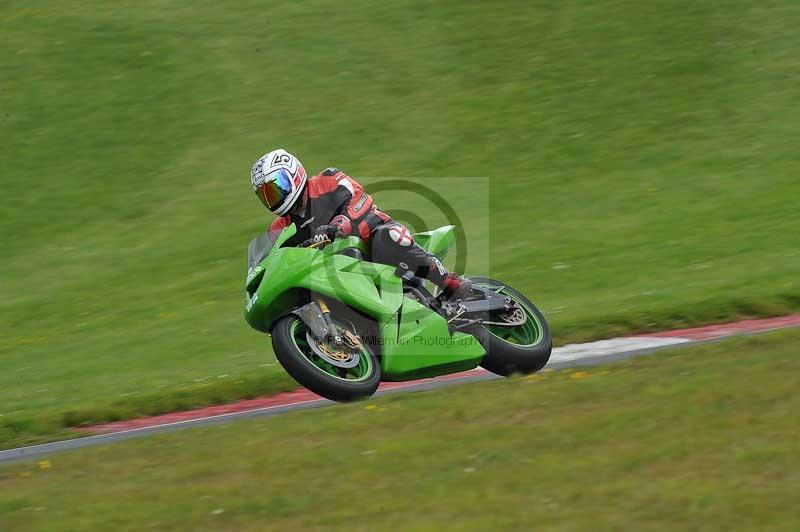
[{"x1": 250, "y1": 148, "x2": 306, "y2": 216}]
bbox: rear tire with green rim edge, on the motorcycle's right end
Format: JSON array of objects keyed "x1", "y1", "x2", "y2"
[{"x1": 470, "y1": 277, "x2": 553, "y2": 377}]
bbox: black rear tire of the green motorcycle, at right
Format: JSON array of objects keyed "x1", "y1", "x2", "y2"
[{"x1": 470, "y1": 277, "x2": 553, "y2": 377}]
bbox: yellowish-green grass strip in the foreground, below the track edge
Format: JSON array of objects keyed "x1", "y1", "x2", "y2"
[{"x1": 0, "y1": 331, "x2": 800, "y2": 532}]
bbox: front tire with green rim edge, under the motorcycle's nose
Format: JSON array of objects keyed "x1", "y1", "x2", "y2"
[{"x1": 272, "y1": 314, "x2": 381, "y2": 402}]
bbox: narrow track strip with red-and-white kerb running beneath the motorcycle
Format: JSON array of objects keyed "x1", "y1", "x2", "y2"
[{"x1": 0, "y1": 314, "x2": 800, "y2": 464}]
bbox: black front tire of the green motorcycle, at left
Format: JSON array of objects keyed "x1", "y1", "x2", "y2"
[{"x1": 272, "y1": 314, "x2": 381, "y2": 402}]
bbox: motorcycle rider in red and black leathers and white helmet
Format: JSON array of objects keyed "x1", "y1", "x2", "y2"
[{"x1": 250, "y1": 149, "x2": 472, "y2": 300}]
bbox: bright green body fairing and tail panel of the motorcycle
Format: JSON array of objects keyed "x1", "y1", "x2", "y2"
[{"x1": 245, "y1": 225, "x2": 485, "y2": 380}]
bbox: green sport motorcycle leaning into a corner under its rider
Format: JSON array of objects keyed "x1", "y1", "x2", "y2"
[{"x1": 245, "y1": 225, "x2": 552, "y2": 401}]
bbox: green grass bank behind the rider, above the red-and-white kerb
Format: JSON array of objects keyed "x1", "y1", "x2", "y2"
[{"x1": 0, "y1": 0, "x2": 800, "y2": 447}]
